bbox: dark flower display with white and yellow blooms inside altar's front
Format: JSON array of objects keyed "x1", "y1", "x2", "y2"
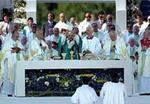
[{"x1": 25, "y1": 69, "x2": 123, "y2": 96}]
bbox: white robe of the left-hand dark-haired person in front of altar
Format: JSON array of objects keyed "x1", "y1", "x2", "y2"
[{"x1": 71, "y1": 85, "x2": 98, "y2": 104}]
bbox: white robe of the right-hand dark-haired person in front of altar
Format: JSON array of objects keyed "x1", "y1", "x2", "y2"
[{"x1": 100, "y1": 82, "x2": 127, "y2": 104}]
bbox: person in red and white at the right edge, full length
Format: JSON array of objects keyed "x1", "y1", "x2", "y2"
[{"x1": 138, "y1": 28, "x2": 150, "y2": 94}]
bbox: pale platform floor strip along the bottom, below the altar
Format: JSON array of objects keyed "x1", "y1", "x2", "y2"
[{"x1": 0, "y1": 96, "x2": 150, "y2": 104}]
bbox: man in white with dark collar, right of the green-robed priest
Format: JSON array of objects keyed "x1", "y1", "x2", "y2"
[{"x1": 82, "y1": 27, "x2": 101, "y2": 56}]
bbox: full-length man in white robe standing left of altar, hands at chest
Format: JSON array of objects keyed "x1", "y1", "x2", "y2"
[{"x1": 1, "y1": 30, "x2": 22, "y2": 95}]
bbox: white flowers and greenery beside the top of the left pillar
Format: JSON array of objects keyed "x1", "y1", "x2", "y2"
[{"x1": 13, "y1": 0, "x2": 26, "y2": 25}]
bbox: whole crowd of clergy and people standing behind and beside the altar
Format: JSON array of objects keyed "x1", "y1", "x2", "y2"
[{"x1": 0, "y1": 11, "x2": 150, "y2": 102}]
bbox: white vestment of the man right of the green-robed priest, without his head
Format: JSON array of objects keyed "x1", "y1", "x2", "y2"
[{"x1": 82, "y1": 37, "x2": 102, "y2": 56}]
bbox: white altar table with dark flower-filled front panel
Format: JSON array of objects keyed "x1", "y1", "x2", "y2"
[{"x1": 15, "y1": 60, "x2": 133, "y2": 97}]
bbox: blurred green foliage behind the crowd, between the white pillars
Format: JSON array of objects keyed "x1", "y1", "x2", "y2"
[{"x1": 37, "y1": 2, "x2": 115, "y2": 26}]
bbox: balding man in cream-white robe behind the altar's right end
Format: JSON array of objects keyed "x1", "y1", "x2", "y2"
[{"x1": 102, "y1": 30, "x2": 128, "y2": 60}]
